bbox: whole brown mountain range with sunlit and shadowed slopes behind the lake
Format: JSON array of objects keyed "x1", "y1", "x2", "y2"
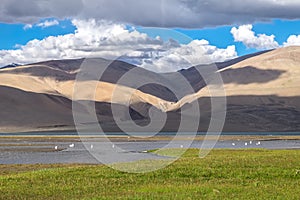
[{"x1": 0, "y1": 46, "x2": 300, "y2": 133}]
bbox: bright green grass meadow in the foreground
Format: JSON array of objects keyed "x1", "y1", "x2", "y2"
[{"x1": 0, "y1": 149, "x2": 300, "y2": 199}]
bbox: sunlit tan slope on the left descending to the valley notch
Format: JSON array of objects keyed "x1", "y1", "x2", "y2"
[{"x1": 0, "y1": 60, "x2": 173, "y2": 110}]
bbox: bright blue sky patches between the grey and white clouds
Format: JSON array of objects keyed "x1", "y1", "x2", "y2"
[{"x1": 0, "y1": 19, "x2": 300, "y2": 56}]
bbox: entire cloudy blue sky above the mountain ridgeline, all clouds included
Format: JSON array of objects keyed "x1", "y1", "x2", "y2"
[{"x1": 0, "y1": 0, "x2": 300, "y2": 72}]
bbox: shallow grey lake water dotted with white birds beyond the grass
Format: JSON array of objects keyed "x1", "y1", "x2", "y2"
[{"x1": 0, "y1": 132, "x2": 300, "y2": 164}]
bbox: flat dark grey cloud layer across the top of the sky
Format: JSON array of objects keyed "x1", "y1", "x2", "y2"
[{"x1": 0, "y1": 0, "x2": 300, "y2": 28}]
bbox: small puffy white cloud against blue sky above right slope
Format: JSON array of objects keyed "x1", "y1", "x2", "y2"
[{"x1": 231, "y1": 24, "x2": 279, "y2": 50}]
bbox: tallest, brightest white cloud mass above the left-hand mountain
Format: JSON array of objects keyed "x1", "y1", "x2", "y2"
[{"x1": 0, "y1": 19, "x2": 162, "y2": 64}]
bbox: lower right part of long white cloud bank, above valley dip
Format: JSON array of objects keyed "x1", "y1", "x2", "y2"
[{"x1": 135, "y1": 40, "x2": 237, "y2": 72}]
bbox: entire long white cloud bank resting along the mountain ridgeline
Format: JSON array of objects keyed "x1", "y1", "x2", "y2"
[{"x1": 0, "y1": 19, "x2": 237, "y2": 72}]
